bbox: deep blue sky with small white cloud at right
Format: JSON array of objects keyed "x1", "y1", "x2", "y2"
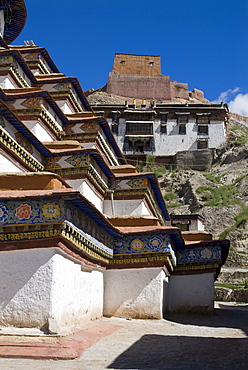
[{"x1": 14, "y1": 0, "x2": 248, "y2": 115}]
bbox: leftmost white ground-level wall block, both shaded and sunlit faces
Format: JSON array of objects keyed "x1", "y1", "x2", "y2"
[{"x1": 0, "y1": 248, "x2": 103, "y2": 333}]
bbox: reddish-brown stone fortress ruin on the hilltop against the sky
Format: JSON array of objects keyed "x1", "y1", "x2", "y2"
[{"x1": 106, "y1": 54, "x2": 204, "y2": 100}]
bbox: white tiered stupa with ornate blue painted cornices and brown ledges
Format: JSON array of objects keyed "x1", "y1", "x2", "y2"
[{"x1": 0, "y1": 0, "x2": 229, "y2": 333}]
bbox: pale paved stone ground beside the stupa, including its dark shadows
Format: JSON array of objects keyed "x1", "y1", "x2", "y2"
[{"x1": 0, "y1": 303, "x2": 248, "y2": 370}]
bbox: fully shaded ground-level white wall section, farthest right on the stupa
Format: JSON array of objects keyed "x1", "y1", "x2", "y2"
[{"x1": 167, "y1": 273, "x2": 214, "y2": 312}]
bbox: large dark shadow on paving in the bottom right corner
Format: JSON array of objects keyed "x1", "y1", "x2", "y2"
[{"x1": 108, "y1": 334, "x2": 248, "y2": 370}]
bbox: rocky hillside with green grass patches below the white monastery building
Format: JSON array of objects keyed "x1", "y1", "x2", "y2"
[{"x1": 156, "y1": 119, "x2": 248, "y2": 284}]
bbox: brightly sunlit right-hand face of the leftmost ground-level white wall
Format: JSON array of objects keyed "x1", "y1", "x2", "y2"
[{"x1": 49, "y1": 254, "x2": 103, "y2": 332}]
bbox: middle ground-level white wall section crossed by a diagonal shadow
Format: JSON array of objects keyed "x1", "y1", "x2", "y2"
[{"x1": 103, "y1": 268, "x2": 167, "y2": 319}]
